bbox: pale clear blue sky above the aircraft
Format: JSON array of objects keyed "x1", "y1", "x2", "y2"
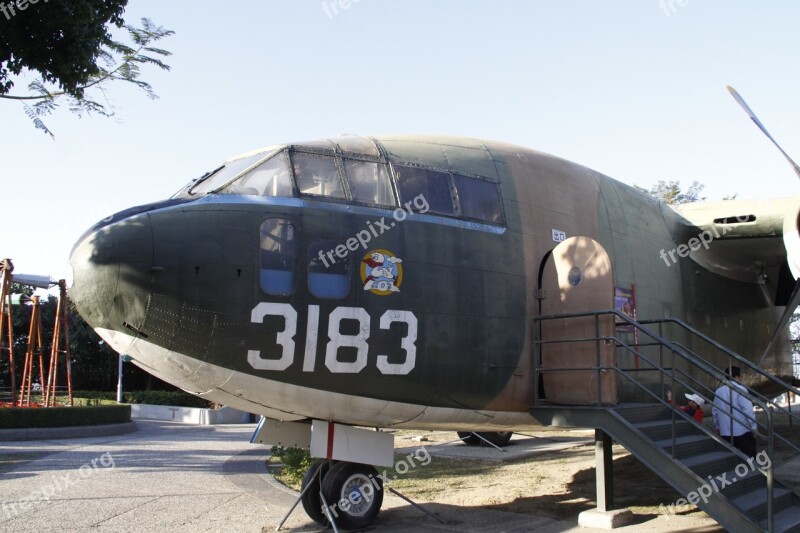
[{"x1": 0, "y1": 0, "x2": 800, "y2": 286}]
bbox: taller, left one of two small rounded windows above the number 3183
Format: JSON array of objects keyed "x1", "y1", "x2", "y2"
[{"x1": 260, "y1": 218, "x2": 297, "y2": 296}]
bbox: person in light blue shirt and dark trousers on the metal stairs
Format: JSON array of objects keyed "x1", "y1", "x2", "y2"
[{"x1": 711, "y1": 366, "x2": 758, "y2": 457}]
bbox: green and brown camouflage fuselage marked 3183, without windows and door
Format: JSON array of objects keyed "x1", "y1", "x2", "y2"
[{"x1": 72, "y1": 136, "x2": 789, "y2": 428}]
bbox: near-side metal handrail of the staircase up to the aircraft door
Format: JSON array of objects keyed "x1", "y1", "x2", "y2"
[{"x1": 534, "y1": 309, "x2": 774, "y2": 531}]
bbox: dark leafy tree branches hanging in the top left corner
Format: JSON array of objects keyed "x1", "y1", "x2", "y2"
[{"x1": 0, "y1": 0, "x2": 174, "y2": 137}]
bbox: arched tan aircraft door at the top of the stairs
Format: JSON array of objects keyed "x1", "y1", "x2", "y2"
[{"x1": 538, "y1": 236, "x2": 617, "y2": 405}]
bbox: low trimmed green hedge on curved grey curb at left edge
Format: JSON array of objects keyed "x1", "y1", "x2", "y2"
[{"x1": 0, "y1": 405, "x2": 131, "y2": 429}]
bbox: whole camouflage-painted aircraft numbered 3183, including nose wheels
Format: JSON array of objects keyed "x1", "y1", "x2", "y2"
[{"x1": 70, "y1": 87, "x2": 800, "y2": 527}]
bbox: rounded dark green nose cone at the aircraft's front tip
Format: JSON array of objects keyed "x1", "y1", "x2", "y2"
[{"x1": 70, "y1": 213, "x2": 153, "y2": 332}]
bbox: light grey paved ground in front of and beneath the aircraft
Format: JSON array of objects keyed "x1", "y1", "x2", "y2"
[{"x1": 0, "y1": 421, "x2": 718, "y2": 533}]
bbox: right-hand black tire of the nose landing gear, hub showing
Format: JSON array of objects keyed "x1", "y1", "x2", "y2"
[{"x1": 322, "y1": 461, "x2": 383, "y2": 529}]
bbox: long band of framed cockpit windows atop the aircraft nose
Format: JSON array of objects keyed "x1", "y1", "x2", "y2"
[{"x1": 173, "y1": 136, "x2": 505, "y2": 226}]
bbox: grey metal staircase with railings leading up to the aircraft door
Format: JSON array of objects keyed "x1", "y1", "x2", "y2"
[{"x1": 531, "y1": 311, "x2": 800, "y2": 532}]
